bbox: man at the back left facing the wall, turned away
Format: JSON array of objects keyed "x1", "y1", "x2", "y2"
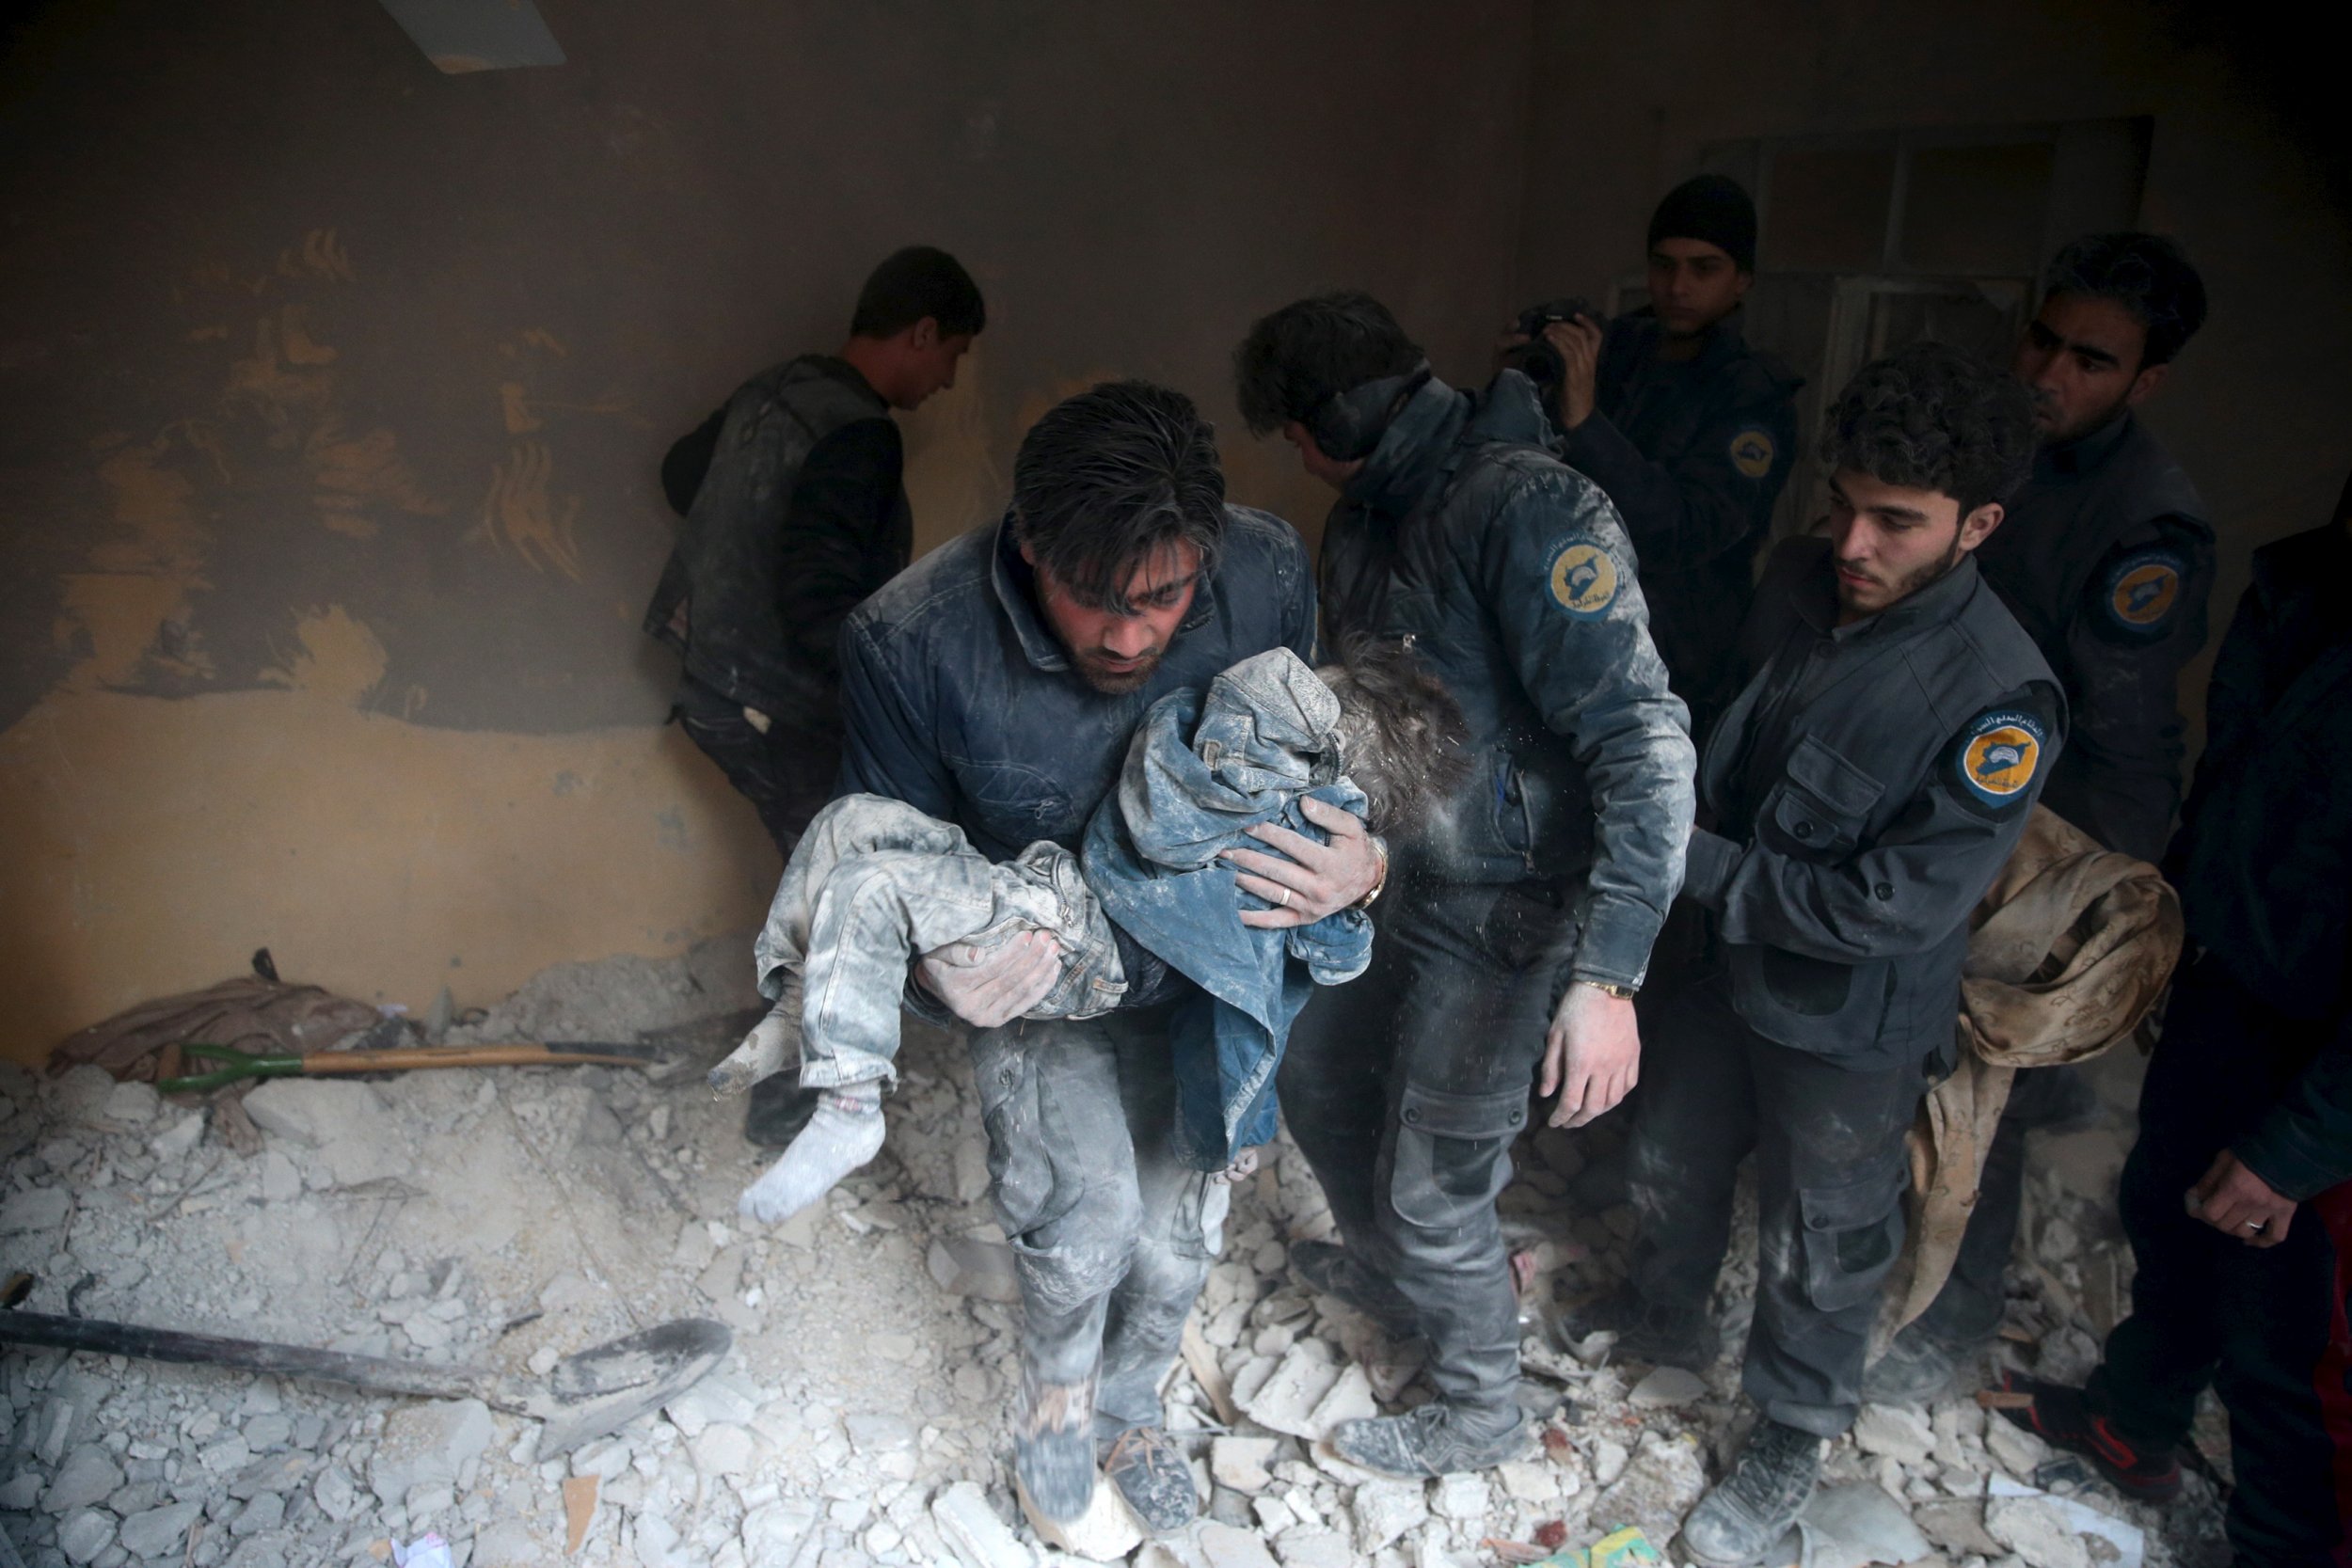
[{"x1": 644, "y1": 246, "x2": 986, "y2": 1148}]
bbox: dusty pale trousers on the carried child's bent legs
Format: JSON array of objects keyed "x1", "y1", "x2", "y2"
[{"x1": 753, "y1": 795, "x2": 1127, "y2": 1088}]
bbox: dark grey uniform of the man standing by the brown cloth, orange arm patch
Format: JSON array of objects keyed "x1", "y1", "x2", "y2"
[{"x1": 1630, "y1": 538, "x2": 2065, "y2": 1436}]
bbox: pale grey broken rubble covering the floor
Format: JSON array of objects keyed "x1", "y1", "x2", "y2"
[{"x1": 0, "y1": 942, "x2": 2220, "y2": 1568}]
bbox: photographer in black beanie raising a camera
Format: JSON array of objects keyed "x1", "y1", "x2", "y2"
[{"x1": 1503, "y1": 174, "x2": 1804, "y2": 740}]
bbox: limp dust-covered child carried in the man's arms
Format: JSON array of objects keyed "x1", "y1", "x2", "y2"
[{"x1": 710, "y1": 646, "x2": 1461, "y2": 1223}]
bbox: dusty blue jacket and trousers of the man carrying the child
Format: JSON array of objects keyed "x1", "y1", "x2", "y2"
[{"x1": 842, "y1": 505, "x2": 1315, "y2": 1425}]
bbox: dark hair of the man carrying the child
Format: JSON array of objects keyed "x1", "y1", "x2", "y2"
[{"x1": 1014, "y1": 381, "x2": 1226, "y2": 611}]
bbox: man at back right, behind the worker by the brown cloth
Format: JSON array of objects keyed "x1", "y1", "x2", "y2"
[{"x1": 1866, "y1": 232, "x2": 2214, "y2": 1402}]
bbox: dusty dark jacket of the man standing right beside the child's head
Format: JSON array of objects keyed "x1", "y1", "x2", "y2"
[{"x1": 1325, "y1": 372, "x2": 1693, "y2": 985}]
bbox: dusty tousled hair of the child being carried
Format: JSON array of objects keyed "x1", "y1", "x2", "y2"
[{"x1": 1317, "y1": 637, "x2": 1470, "y2": 832}]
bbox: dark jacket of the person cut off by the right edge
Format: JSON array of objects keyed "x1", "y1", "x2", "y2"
[{"x1": 2159, "y1": 510, "x2": 2352, "y2": 1199}]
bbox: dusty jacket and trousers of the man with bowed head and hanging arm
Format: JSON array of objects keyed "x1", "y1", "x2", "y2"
[{"x1": 1282, "y1": 372, "x2": 1693, "y2": 1434}]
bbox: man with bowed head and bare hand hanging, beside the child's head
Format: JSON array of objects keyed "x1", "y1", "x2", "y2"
[{"x1": 1235, "y1": 293, "x2": 1693, "y2": 1477}]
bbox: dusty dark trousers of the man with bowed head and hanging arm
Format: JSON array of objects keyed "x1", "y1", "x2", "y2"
[{"x1": 1279, "y1": 881, "x2": 1574, "y2": 1427}]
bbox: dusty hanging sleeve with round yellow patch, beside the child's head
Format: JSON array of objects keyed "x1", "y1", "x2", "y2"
[{"x1": 1480, "y1": 467, "x2": 1698, "y2": 985}]
